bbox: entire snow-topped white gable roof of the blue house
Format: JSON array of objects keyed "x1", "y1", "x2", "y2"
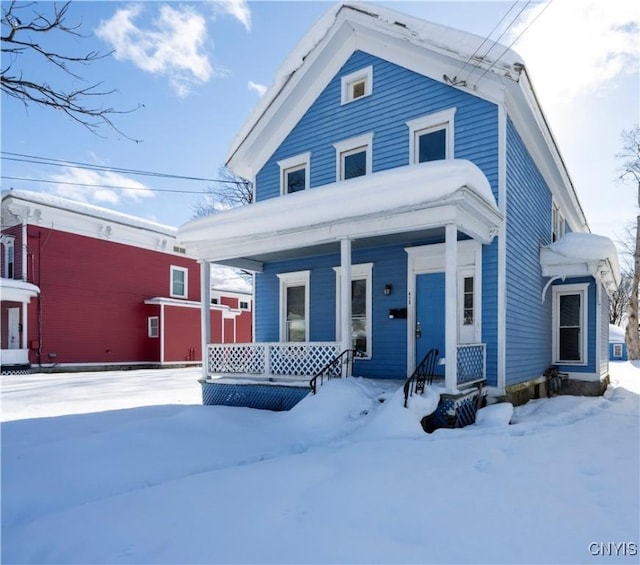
[{"x1": 226, "y1": 3, "x2": 589, "y2": 231}]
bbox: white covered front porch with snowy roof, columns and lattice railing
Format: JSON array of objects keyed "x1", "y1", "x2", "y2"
[{"x1": 178, "y1": 160, "x2": 502, "y2": 406}]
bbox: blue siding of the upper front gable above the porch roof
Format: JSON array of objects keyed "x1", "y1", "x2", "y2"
[{"x1": 256, "y1": 51, "x2": 498, "y2": 200}]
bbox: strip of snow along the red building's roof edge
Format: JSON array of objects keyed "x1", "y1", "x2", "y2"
[{"x1": 2, "y1": 189, "x2": 177, "y2": 237}]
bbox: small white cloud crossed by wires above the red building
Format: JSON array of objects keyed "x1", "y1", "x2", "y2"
[{"x1": 51, "y1": 167, "x2": 154, "y2": 204}]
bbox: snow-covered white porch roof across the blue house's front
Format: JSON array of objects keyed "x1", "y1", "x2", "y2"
[{"x1": 178, "y1": 159, "x2": 502, "y2": 271}]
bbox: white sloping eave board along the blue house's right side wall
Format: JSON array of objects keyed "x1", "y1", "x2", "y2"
[{"x1": 507, "y1": 70, "x2": 590, "y2": 232}]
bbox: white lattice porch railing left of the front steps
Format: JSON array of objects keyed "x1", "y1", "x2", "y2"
[{"x1": 207, "y1": 341, "x2": 340, "y2": 377}]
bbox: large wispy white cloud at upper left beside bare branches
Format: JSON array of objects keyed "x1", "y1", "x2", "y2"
[{"x1": 96, "y1": 4, "x2": 213, "y2": 97}]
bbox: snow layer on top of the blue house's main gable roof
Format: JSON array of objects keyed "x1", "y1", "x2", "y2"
[{"x1": 227, "y1": 2, "x2": 523, "y2": 165}]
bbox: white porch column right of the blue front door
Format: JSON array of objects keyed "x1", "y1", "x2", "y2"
[{"x1": 444, "y1": 224, "x2": 458, "y2": 392}]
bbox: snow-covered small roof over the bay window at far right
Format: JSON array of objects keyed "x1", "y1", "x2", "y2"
[{"x1": 540, "y1": 233, "x2": 620, "y2": 294}]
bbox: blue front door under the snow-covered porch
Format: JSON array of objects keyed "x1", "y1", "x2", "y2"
[{"x1": 416, "y1": 273, "x2": 445, "y2": 375}]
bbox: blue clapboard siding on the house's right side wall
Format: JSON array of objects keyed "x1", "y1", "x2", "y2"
[{"x1": 506, "y1": 119, "x2": 552, "y2": 386}]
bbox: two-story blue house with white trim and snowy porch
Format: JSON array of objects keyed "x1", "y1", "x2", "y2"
[{"x1": 179, "y1": 4, "x2": 619, "y2": 412}]
